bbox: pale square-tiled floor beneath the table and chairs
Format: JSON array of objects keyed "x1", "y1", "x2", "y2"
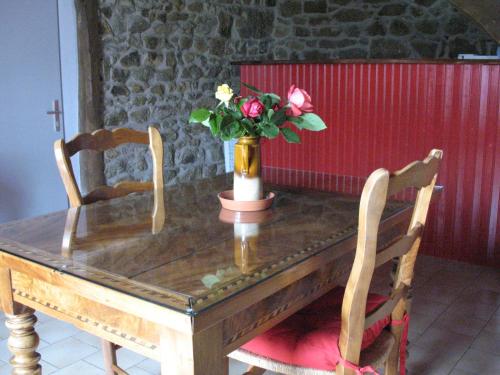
[{"x1": 0, "y1": 256, "x2": 500, "y2": 375}]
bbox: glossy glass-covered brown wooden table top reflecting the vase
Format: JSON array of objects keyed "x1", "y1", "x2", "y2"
[{"x1": 0, "y1": 175, "x2": 408, "y2": 313}]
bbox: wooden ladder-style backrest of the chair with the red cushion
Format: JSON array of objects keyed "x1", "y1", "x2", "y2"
[{"x1": 337, "y1": 150, "x2": 443, "y2": 374}]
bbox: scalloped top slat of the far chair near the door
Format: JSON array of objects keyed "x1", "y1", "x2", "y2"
[{"x1": 66, "y1": 128, "x2": 149, "y2": 156}]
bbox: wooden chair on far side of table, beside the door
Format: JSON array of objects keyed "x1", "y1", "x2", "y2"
[{"x1": 54, "y1": 127, "x2": 165, "y2": 375}]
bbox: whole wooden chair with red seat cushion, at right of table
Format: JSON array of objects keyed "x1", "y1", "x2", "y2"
[{"x1": 229, "y1": 150, "x2": 442, "y2": 375}]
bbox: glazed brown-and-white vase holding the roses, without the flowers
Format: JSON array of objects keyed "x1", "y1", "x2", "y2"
[{"x1": 233, "y1": 137, "x2": 263, "y2": 201}]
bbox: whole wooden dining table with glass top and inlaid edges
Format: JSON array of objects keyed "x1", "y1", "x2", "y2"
[{"x1": 0, "y1": 176, "x2": 411, "y2": 375}]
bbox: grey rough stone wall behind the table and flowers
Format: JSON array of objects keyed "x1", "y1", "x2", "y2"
[{"x1": 99, "y1": 0, "x2": 496, "y2": 184}]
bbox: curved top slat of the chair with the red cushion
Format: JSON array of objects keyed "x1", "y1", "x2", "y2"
[{"x1": 387, "y1": 150, "x2": 442, "y2": 196}]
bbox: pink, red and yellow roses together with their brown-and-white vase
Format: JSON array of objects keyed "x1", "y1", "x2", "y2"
[{"x1": 189, "y1": 83, "x2": 326, "y2": 207}]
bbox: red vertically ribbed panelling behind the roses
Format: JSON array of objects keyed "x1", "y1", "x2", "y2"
[{"x1": 241, "y1": 62, "x2": 500, "y2": 265}]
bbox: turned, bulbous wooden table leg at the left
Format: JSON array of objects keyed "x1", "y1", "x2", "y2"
[{"x1": 5, "y1": 308, "x2": 42, "y2": 375}]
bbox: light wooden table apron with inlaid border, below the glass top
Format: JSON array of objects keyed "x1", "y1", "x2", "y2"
[{"x1": 0, "y1": 209, "x2": 410, "y2": 375}]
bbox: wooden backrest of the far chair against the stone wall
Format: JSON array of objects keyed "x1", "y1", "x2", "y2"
[{"x1": 54, "y1": 126, "x2": 163, "y2": 207}]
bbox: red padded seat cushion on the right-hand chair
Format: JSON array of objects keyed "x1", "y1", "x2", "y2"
[{"x1": 242, "y1": 288, "x2": 390, "y2": 371}]
